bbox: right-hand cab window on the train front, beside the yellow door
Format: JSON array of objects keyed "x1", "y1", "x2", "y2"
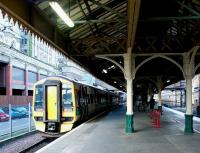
[{"x1": 62, "y1": 84, "x2": 73, "y2": 109}]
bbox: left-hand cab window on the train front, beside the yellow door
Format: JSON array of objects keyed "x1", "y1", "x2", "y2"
[{"x1": 34, "y1": 85, "x2": 44, "y2": 111}]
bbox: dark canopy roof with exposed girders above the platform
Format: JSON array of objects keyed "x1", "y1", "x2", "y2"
[{"x1": 1, "y1": 0, "x2": 200, "y2": 90}]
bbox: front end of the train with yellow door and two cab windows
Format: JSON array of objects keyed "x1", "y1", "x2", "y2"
[{"x1": 33, "y1": 78, "x2": 77, "y2": 135}]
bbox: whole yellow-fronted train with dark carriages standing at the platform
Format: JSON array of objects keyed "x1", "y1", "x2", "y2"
[{"x1": 33, "y1": 76, "x2": 119, "y2": 135}]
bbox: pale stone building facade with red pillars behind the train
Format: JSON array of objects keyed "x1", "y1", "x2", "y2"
[{"x1": 0, "y1": 12, "x2": 67, "y2": 104}]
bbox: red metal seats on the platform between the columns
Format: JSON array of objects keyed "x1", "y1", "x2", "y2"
[{"x1": 149, "y1": 109, "x2": 161, "y2": 128}]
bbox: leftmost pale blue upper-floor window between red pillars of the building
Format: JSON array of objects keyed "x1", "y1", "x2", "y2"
[{"x1": 12, "y1": 67, "x2": 25, "y2": 81}]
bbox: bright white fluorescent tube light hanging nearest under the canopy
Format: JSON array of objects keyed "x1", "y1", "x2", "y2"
[{"x1": 49, "y1": 1, "x2": 74, "y2": 27}]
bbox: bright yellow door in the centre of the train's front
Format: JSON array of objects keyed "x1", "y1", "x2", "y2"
[{"x1": 46, "y1": 86, "x2": 58, "y2": 121}]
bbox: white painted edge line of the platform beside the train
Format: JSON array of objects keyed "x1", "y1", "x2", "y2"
[{"x1": 36, "y1": 111, "x2": 106, "y2": 153}]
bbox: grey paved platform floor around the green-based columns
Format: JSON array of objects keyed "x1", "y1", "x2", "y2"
[{"x1": 37, "y1": 106, "x2": 200, "y2": 153}]
